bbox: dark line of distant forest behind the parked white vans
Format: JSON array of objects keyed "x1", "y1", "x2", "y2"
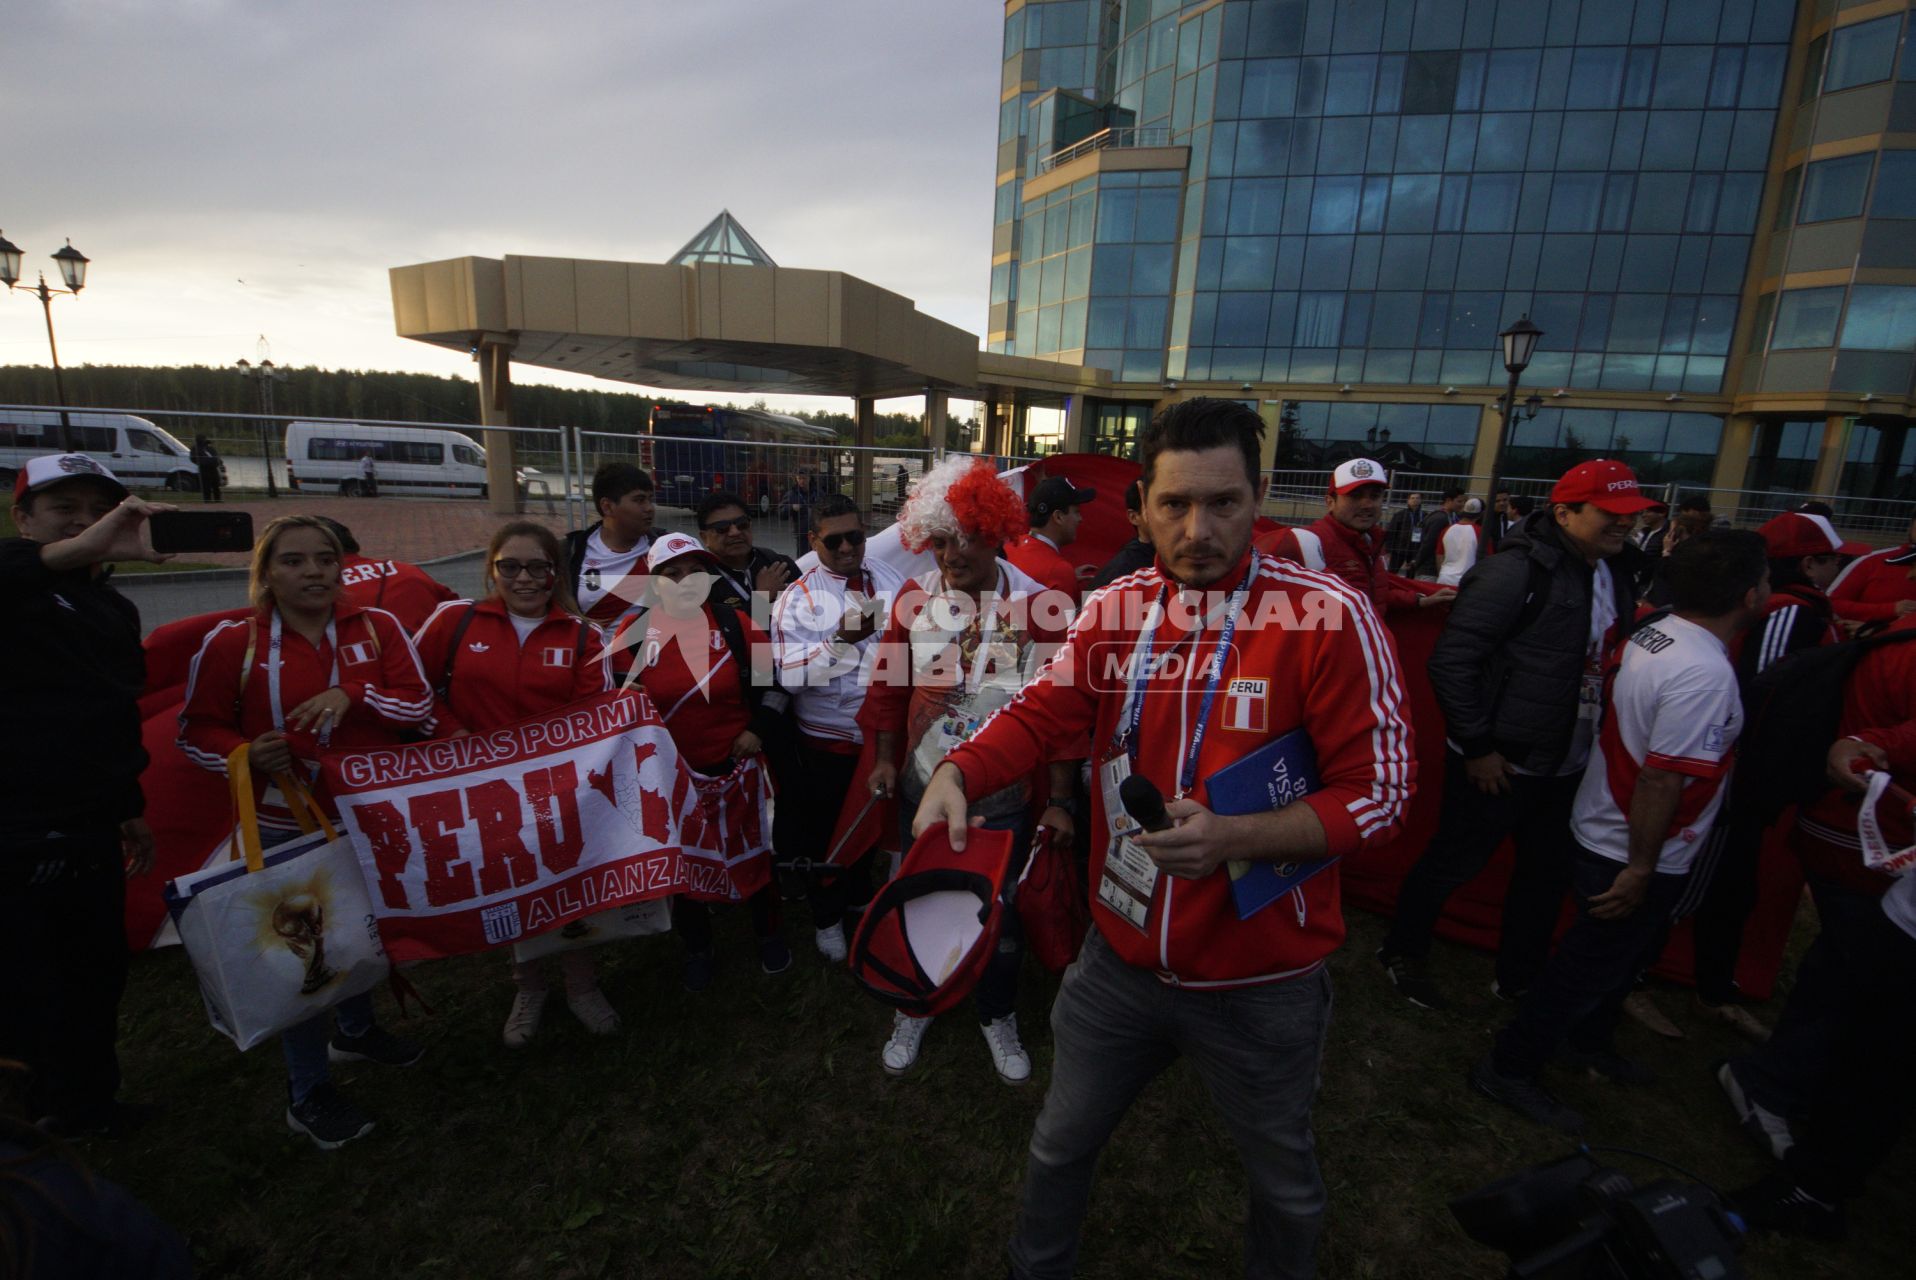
[{"x1": 0, "y1": 364, "x2": 956, "y2": 446}]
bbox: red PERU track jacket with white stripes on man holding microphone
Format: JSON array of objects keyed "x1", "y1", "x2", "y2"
[{"x1": 948, "y1": 552, "x2": 1416, "y2": 987}]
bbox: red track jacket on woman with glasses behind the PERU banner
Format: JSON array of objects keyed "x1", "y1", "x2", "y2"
[{"x1": 414, "y1": 598, "x2": 611, "y2": 736}]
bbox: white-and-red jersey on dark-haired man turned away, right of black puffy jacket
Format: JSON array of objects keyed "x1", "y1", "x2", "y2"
[{"x1": 1569, "y1": 615, "x2": 1744, "y2": 874}]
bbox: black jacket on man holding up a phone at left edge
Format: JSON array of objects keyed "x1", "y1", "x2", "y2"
[{"x1": 0, "y1": 538, "x2": 146, "y2": 835}]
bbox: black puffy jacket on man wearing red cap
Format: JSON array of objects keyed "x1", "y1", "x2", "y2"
[{"x1": 1429, "y1": 512, "x2": 1642, "y2": 774}]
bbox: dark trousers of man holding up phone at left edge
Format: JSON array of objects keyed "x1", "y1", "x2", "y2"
[{"x1": 0, "y1": 826, "x2": 126, "y2": 1121}]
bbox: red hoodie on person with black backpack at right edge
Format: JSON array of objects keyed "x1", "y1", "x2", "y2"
[{"x1": 1793, "y1": 615, "x2": 1916, "y2": 893}]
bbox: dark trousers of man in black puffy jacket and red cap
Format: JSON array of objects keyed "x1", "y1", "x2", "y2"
[{"x1": 1383, "y1": 751, "x2": 1581, "y2": 993}]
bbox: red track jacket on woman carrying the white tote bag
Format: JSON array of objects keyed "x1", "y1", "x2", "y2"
[{"x1": 180, "y1": 600, "x2": 433, "y2": 832}]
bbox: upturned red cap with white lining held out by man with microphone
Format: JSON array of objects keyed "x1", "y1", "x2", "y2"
[{"x1": 851, "y1": 824, "x2": 1015, "y2": 1017}]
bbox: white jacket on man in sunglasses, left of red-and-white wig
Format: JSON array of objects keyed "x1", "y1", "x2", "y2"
[{"x1": 772, "y1": 561, "x2": 904, "y2": 743}]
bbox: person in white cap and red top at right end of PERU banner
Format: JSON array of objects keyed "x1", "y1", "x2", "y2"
[{"x1": 609, "y1": 533, "x2": 791, "y2": 991}]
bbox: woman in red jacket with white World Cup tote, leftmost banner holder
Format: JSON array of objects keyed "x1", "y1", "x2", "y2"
[{"x1": 180, "y1": 515, "x2": 433, "y2": 1150}]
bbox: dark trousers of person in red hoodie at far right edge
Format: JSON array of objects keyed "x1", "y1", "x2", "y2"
[{"x1": 1755, "y1": 889, "x2": 1916, "y2": 1201}]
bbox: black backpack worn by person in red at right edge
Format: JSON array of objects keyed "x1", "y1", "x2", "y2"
[{"x1": 1732, "y1": 630, "x2": 1916, "y2": 826}]
